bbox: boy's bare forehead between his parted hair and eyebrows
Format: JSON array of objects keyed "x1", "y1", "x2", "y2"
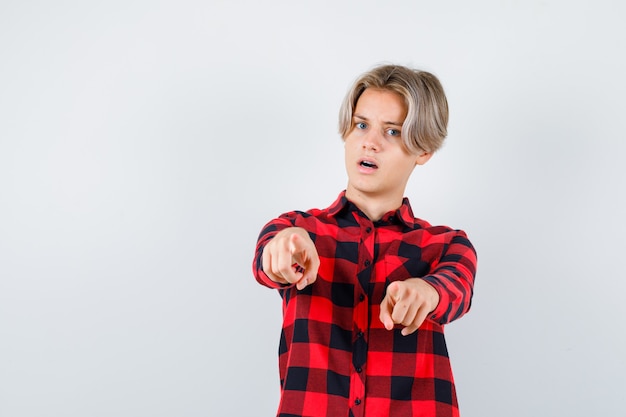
[{"x1": 354, "y1": 88, "x2": 407, "y2": 123}]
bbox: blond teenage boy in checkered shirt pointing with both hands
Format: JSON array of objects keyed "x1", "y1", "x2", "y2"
[{"x1": 253, "y1": 65, "x2": 476, "y2": 417}]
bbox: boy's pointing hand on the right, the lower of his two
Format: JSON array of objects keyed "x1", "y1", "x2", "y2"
[{"x1": 379, "y1": 278, "x2": 439, "y2": 336}]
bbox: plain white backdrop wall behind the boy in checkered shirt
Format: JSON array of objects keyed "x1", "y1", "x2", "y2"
[{"x1": 0, "y1": 0, "x2": 626, "y2": 417}]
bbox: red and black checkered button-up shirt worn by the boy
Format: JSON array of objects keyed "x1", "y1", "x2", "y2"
[{"x1": 253, "y1": 192, "x2": 476, "y2": 417}]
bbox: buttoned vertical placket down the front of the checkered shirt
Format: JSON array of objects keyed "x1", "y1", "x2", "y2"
[{"x1": 349, "y1": 217, "x2": 375, "y2": 417}]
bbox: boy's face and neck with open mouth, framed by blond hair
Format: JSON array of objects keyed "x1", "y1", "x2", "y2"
[{"x1": 345, "y1": 88, "x2": 430, "y2": 204}]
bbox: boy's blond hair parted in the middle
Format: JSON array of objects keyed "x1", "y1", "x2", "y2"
[{"x1": 339, "y1": 65, "x2": 448, "y2": 153}]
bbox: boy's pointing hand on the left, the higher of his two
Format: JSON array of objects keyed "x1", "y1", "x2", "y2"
[{"x1": 263, "y1": 227, "x2": 320, "y2": 290}]
